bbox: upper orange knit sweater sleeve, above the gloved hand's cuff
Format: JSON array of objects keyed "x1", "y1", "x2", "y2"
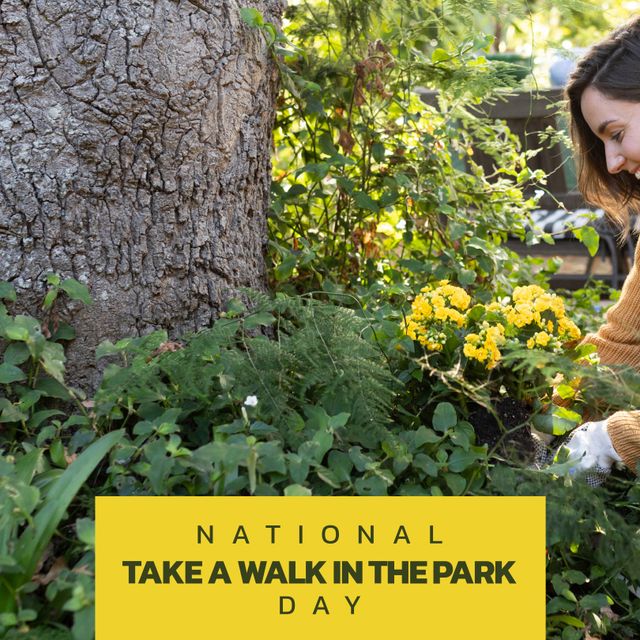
[{"x1": 582, "y1": 242, "x2": 640, "y2": 369}]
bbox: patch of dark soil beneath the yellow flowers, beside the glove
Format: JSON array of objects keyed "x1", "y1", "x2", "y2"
[{"x1": 469, "y1": 398, "x2": 536, "y2": 464}]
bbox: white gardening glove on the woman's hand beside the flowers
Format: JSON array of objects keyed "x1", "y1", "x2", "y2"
[{"x1": 562, "y1": 420, "x2": 622, "y2": 486}]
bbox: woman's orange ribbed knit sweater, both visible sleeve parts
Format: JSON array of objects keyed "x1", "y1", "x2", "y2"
[{"x1": 583, "y1": 242, "x2": 640, "y2": 471}]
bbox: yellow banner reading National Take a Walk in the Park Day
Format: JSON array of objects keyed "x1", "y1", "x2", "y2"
[{"x1": 96, "y1": 496, "x2": 545, "y2": 640}]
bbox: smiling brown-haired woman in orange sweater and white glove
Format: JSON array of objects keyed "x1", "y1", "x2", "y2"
[{"x1": 565, "y1": 18, "x2": 640, "y2": 473}]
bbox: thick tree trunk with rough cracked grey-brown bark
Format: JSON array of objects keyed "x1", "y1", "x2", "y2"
[{"x1": 0, "y1": 0, "x2": 281, "y2": 384}]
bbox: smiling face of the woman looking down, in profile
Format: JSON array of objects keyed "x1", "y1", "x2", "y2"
[{"x1": 580, "y1": 87, "x2": 640, "y2": 180}]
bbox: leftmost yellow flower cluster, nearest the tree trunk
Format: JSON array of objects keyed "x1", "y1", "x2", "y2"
[{"x1": 406, "y1": 280, "x2": 471, "y2": 351}]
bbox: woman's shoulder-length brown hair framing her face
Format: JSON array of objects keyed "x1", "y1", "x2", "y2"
[{"x1": 565, "y1": 17, "x2": 640, "y2": 231}]
